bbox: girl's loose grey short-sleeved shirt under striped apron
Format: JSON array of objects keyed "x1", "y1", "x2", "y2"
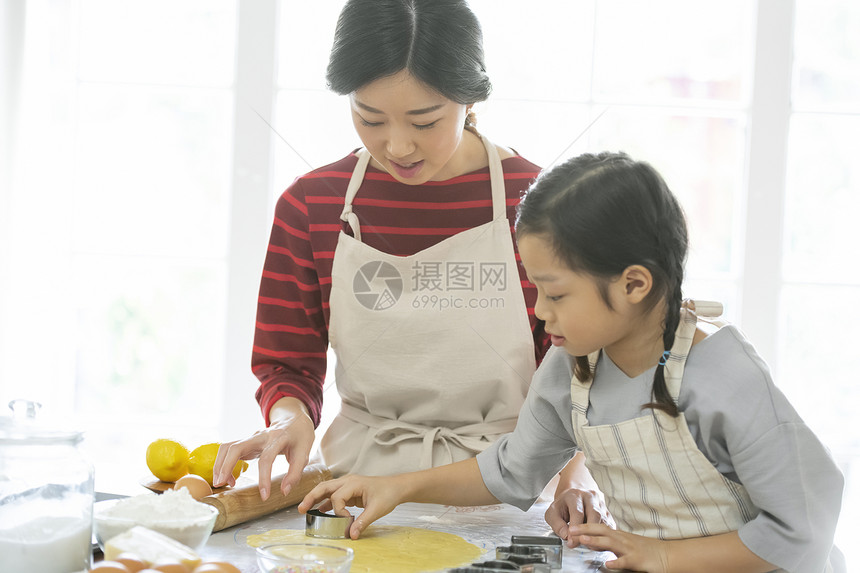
[{"x1": 477, "y1": 326, "x2": 843, "y2": 573}]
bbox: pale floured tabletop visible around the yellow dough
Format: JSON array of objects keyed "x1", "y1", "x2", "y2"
[{"x1": 200, "y1": 502, "x2": 612, "y2": 573}]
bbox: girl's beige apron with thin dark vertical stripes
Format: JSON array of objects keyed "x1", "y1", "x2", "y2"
[{"x1": 570, "y1": 301, "x2": 832, "y2": 572}]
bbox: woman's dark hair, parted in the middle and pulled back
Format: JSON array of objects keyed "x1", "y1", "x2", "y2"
[{"x1": 326, "y1": 0, "x2": 491, "y2": 105}]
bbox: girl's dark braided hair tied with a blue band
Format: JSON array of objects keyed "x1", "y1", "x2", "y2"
[{"x1": 517, "y1": 152, "x2": 688, "y2": 416}]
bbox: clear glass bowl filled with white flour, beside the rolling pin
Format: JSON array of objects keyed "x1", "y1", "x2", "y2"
[{"x1": 93, "y1": 499, "x2": 218, "y2": 551}]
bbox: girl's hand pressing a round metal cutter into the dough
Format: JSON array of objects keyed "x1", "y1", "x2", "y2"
[{"x1": 298, "y1": 476, "x2": 405, "y2": 539}]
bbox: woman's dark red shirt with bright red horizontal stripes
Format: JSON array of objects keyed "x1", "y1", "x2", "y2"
[{"x1": 251, "y1": 150, "x2": 546, "y2": 424}]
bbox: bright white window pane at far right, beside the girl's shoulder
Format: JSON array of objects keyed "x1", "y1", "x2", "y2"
[{"x1": 788, "y1": 0, "x2": 860, "y2": 570}]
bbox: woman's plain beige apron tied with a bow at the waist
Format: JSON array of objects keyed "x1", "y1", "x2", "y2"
[{"x1": 320, "y1": 137, "x2": 535, "y2": 475}]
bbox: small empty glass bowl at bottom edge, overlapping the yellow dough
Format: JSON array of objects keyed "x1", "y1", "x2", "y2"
[{"x1": 257, "y1": 543, "x2": 353, "y2": 573}]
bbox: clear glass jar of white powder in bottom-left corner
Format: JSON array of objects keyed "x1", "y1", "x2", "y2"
[{"x1": 0, "y1": 400, "x2": 93, "y2": 573}]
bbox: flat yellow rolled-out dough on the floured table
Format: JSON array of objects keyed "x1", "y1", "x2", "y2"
[{"x1": 247, "y1": 525, "x2": 484, "y2": 573}]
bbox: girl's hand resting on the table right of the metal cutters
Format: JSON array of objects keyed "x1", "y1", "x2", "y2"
[{"x1": 570, "y1": 523, "x2": 669, "y2": 573}]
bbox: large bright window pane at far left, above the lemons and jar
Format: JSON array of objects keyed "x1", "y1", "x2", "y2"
[{"x1": 0, "y1": 0, "x2": 250, "y2": 488}]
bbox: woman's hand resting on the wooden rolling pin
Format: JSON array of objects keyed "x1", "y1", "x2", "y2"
[{"x1": 212, "y1": 398, "x2": 314, "y2": 500}]
